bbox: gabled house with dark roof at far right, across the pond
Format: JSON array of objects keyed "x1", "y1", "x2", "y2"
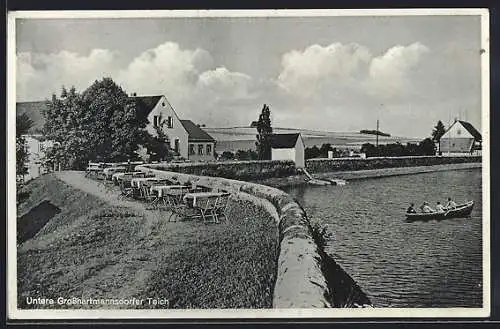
[{"x1": 439, "y1": 120, "x2": 481, "y2": 155}]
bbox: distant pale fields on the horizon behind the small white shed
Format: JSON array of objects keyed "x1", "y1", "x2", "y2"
[{"x1": 204, "y1": 127, "x2": 420, "y2": 152}]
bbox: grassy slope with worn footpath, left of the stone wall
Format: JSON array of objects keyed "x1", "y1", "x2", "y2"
[{"x1": 17, "y1": 175, "x2": 277, "y2": 308}]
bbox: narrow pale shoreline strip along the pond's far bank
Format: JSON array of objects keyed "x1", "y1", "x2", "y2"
[{"x1": 254, "y1": 162, "x2": 482, "y2": 188}]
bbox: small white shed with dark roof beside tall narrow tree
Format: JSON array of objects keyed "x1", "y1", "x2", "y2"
[{"x1": 271, "y1": 133, "x2": 305, "y2": 168}]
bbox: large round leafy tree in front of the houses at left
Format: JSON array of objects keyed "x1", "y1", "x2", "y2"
[{"x1": 44, "y1": 78, "x2": 147, "y2": 169}]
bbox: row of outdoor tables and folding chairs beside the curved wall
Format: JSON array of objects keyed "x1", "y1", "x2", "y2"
[{"x1": 85, "y1": 164, "x2": 231, "y2": 223}]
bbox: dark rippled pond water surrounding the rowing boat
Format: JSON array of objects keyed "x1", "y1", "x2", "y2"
[{"x1": 286, "y1": 169, "x2": 483, "y2": 307}]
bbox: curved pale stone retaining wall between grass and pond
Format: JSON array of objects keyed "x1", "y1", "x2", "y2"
[{"x1": 136, "y1": 164, "x2": 332, "y2": 308}]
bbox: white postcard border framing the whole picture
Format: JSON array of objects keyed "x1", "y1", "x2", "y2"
[{"x1": 7, "y1": 8, "x2": 491, "y2": 320}]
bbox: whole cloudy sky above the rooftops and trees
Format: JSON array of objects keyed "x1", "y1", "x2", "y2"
[{"x1": 16, "y1": 16, "x2": 481, "y2": 137}]
